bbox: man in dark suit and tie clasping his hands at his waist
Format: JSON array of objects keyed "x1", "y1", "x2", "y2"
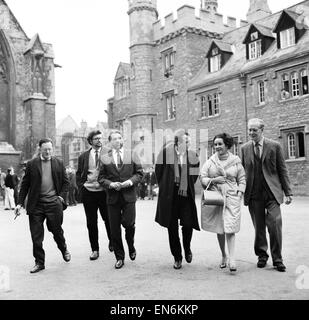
[{"x1": 99, "y1": 131, "x2": 143, "y2": 269}]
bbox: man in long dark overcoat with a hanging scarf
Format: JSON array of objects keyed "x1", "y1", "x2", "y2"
[{"x1": 155, "y1": 131, "x2": 200, "y2": 269}]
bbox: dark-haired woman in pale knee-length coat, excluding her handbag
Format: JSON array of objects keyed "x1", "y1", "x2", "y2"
[{"x1": 200, "y1": 133, "x2": 246, "y2": 272}]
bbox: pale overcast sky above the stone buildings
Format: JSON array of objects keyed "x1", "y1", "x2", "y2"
[{"x1": 6, "y1": 0, "x2": 301, "y2": 126}]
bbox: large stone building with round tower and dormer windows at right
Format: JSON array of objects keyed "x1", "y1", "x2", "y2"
[{"x1": 108, "y1": 0, "x2": 309, "y2": 195}]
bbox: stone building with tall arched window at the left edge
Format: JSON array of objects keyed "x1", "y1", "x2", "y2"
[{"x1": 0, "y1": 0, "x2": 56, "y2": 169}]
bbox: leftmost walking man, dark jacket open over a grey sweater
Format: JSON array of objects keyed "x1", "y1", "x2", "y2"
[{"x1": 15, "y1": 139, "x2": 71, "y2": 273}]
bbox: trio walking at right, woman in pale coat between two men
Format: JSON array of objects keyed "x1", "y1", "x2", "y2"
[{"x1": 156, "y1": 119, "x2": 292, "y2": 272}]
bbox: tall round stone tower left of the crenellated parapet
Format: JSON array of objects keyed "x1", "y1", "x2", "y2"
[{"x1": 126, "y1": 0, "x2": 158, "y2": 141}]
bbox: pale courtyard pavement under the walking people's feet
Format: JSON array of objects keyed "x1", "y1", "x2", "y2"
[{"x1": 0, "y1": 197, "x2": 309, "y2": 300}]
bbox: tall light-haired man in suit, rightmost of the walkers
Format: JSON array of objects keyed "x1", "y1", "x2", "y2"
[{"x1": 241, "y1": 119, "x2": 292, "y2": 272}]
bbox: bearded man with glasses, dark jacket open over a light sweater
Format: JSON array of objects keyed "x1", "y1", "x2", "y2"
[{"x1": 76, "y1": 130, "x2": 113, "y2": 260}]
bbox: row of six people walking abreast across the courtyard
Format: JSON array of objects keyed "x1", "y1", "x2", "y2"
[{"x1": 15, "y1": 119, "x2": 292, "y2": 273}]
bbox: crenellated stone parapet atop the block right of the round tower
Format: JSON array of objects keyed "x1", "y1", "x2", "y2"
[{"x1": 153, "y1": 5, "x2": 241, "y2": 41}]
